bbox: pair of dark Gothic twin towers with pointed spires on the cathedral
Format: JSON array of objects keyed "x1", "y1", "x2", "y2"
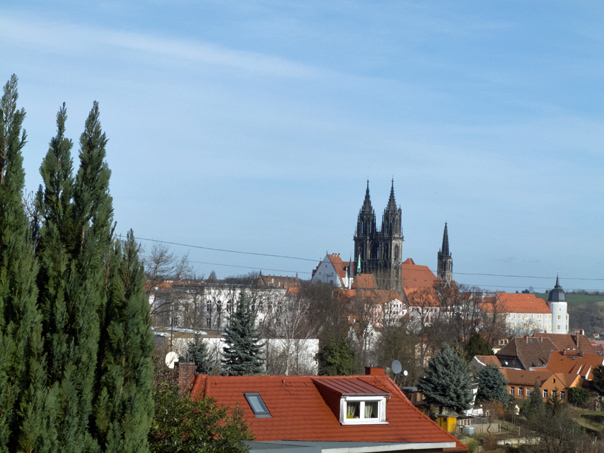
[{"x1": 354, "y1": 180, "x2": 403, "y2": 291}]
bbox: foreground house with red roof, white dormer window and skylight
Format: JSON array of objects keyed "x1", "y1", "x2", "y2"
[{"x1": 186, "y1": 368, "x2": 468, "y2": 453}]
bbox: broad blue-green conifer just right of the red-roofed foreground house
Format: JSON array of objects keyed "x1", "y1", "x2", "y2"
[{"x1": 418, "y1": 345, "x2": 472, "y2": 413}]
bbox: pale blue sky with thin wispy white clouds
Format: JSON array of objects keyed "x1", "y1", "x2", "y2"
[{"x1": 0, "y1": 0, "x2": 604, "y2": 291}]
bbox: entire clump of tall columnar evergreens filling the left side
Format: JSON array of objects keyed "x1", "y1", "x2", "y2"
[{"x1": 0, "y1": 76, "x2": 153, "y2": 452}]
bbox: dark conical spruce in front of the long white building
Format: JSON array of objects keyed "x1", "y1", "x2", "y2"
[{"x1": 222, "y1": 292, "x2": 264, "y2": 376}]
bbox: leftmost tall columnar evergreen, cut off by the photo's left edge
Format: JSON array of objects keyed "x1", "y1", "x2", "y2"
[{"x1": 0, "y1": 75, "x2": 56, "y2": 451}]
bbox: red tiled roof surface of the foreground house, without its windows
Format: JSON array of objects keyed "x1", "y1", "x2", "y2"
[{"x1": 191, "y1": 375, "x2": 467, "y2": 451}]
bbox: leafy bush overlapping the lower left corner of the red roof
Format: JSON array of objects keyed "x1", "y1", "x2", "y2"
[{"x1": 149, "y1": 384, "x2": 253, "y2": 453}]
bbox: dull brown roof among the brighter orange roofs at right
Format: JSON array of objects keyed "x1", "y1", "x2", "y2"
[{"x1": 496, "y1": 337, "x2": 556, "y2": 370}]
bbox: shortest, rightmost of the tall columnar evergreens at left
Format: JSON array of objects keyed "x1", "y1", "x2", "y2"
[{"x1": 95, "y1": 231, "x2": 154, "y2": 452}]
